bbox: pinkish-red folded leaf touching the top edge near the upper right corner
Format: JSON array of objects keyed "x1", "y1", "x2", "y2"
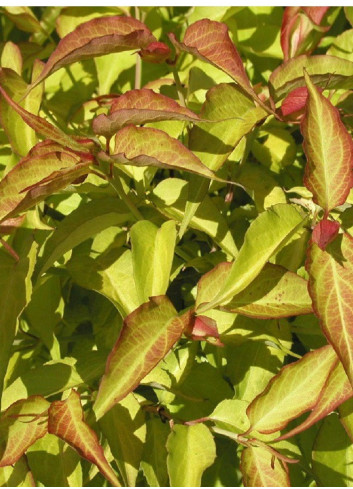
[{"x1": 281, "y1": 7, "x2": 329, "y2": 61}]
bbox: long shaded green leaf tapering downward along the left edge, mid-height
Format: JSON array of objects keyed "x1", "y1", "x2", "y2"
[{"x1": 0, "y1": 234, "x2": 38, "y2": 400}]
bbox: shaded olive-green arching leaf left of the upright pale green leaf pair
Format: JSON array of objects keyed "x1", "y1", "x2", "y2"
[{"x1": 36, "y1": 197, "x2": 131, "y2": 277}]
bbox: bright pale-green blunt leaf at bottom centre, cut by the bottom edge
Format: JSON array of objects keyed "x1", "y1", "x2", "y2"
[{"x1": 167, "y1": 424, "x2": 216, "y2": 487}]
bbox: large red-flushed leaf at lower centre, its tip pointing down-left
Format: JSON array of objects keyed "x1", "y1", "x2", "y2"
[{"x1": 93, "y1": 296, "x2": 191, "y2": 419}]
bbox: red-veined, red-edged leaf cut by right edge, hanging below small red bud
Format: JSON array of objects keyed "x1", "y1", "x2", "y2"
[{"x1": 306, "y1": 228, "x2": 353, "y2": 385}]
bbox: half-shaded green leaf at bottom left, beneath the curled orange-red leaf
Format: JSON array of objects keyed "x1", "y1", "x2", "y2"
[{"x1": 27, "y1": 433, "x2": 83, "y2": 487}]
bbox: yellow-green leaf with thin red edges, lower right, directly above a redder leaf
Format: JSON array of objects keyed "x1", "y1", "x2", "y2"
[{"x1": 243, "y1": 345, "x2": 337, "y2": 433}]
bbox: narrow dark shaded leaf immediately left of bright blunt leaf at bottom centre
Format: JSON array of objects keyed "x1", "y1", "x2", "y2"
[{"x1": 141, "y1": 416, "x2": 170, "y2": 487}]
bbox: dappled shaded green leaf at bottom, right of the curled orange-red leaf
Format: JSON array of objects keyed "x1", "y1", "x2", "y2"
[{"x1": 99, "y1": 394, "x2": 146, "y2": 487}]
